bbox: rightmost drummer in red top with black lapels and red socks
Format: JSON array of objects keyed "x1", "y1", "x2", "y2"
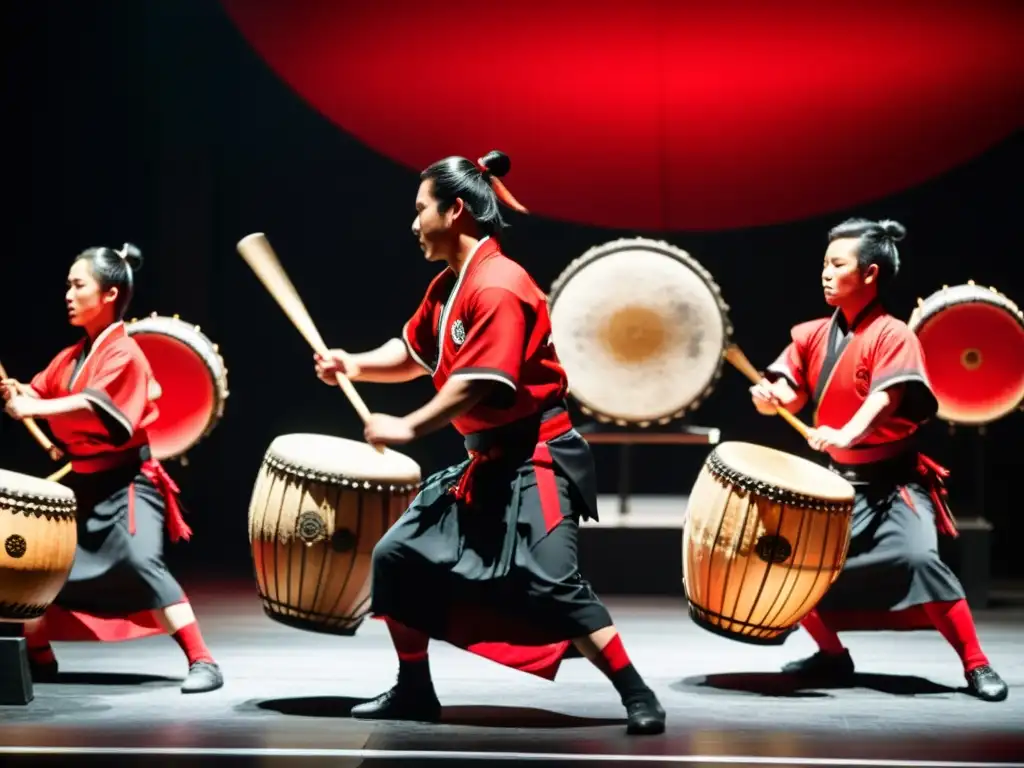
[{"x1": 752, "y1": 219, "x2": 1008, "y2": 701}]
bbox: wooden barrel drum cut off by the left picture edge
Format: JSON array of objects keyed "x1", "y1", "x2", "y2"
[{"x1": 0, "y1": 469, "x2": 78, "y2": 622}]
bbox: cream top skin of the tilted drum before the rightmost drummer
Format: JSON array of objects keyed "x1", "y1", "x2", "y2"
[{"x1": 715, "y1": 442, "x2": 854, "y2": 502}]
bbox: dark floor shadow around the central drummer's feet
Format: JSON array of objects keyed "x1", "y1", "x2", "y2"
[{"x1": 249, "y1": 696, "x2": 626, "y2": 729}]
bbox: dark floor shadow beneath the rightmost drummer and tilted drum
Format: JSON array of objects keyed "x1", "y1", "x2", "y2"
[{"x1": 669, "y1": 672, "x2": 967, "y2": 698}]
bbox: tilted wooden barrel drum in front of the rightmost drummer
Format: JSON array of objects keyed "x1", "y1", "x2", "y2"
[{"x1": 683, "y1": 442, "x2": 854, "y2": 645}]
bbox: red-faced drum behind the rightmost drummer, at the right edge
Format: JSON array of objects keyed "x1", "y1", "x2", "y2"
[{"x1": 907, "y1": 283, "x2": 1024, "y2": 424}]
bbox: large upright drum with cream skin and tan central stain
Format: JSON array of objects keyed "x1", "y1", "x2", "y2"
[{"x1": 548, "y1": 238, "x2": 732, "y2": 427}]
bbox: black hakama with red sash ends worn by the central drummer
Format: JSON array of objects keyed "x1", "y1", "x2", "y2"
[{"x1": 371, "y1": 411, "x2": 612, "y2": 678}]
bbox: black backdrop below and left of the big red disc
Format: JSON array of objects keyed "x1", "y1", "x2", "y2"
[{"x1": 0, "y1": 0, "x2": 1024, "y2": 577}]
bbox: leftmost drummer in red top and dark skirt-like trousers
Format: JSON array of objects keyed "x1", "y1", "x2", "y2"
[{"x1": 2, "y1": 244, "x2": 223, "y2": 693}]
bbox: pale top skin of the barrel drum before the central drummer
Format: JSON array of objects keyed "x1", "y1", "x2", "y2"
[{"x1": 267, "y1": 434, "x2": 421, "y2": 484}]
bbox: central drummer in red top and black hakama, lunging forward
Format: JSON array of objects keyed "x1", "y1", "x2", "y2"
[{"x1": 317, "y1": 152, "x2": 665, "y2": 733}]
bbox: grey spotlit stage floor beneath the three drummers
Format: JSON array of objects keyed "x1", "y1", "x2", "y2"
[{"x1": 0, "y1": 581, "x2": 1024, "y2": 766}]
